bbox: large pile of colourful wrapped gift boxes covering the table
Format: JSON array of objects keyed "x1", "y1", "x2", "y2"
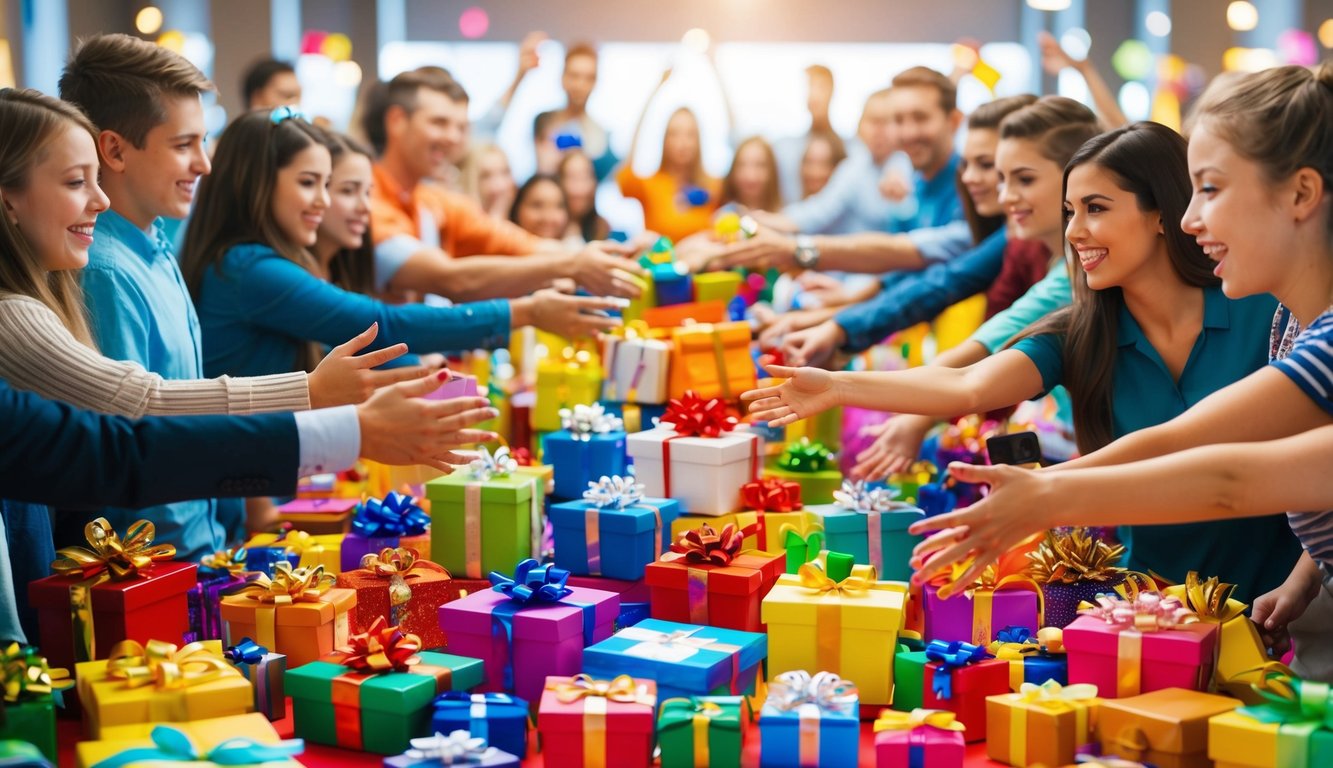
[{"x1": 0, "y1": 237, "x2": 1333, "y2": 768}]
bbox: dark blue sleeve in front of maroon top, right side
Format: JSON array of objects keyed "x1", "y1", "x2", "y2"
[{"x1": 834, "y1": 231, "x2": 1006, "y2": 352}]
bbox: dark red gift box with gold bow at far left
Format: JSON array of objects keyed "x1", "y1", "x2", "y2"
[{"x1": 28, "y1": 517, "x2": 197, "y2": 668}]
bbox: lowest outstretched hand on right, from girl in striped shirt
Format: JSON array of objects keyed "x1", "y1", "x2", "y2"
[{"x1": 908, "y1": 461, "x2": 1052, "y2": 597}]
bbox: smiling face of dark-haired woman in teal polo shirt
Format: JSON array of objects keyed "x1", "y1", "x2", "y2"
[{"x1": 1064, "y1": 163, "x2": 1166, "y2": 291}]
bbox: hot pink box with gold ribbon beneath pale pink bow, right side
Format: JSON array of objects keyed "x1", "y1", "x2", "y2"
[{"x1": 1064, "y1": 616, "x2": 1217, "y2": 699}]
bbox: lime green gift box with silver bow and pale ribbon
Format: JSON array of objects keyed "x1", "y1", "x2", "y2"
[{"x1": 425, "y1": 448, "x2": 544, "y2": 579}]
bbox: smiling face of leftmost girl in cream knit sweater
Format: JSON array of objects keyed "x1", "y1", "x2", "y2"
[{"x1": 4, "y1": 125, "x2": 108, "y2": 271}]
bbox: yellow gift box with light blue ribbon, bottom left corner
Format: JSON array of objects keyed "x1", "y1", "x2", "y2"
[{"x1": 76, "y1": 712, "x2": 301, "y2": 768}]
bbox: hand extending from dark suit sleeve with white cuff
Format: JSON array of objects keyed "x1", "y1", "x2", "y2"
[{"x1": 356, "y1": 371, "x2": 499, "y2": 473}]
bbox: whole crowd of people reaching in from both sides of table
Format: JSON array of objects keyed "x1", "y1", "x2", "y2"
[{"x1": 0, "y1": 27, "x2": 1333, "y2": 680}]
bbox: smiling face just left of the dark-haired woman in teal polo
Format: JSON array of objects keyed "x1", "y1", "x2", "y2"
[{"x1": 996, "y1": 139, "x2": 1064, "y2": 253}]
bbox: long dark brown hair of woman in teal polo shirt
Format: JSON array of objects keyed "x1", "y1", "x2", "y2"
[{"x1": 1022, "y1": 123, "x2": 1221, "y2": 453}]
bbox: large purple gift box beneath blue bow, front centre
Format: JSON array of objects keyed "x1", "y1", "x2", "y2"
[{"x1": 440, "y1": 587, "x2": 620, "y2": 701}]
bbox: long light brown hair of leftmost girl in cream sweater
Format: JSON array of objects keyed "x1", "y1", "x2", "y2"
[{"x1": 0, "y1": 88, "x2": 97, "y2": 348}]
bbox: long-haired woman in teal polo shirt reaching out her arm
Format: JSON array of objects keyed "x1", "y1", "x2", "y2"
[{"x1": 744, "y1": 123, "x2": 1300, "y2": 600}]
